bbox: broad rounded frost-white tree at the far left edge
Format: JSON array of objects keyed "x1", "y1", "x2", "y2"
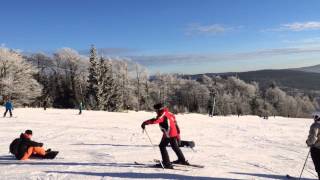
[{"x1": 0, "y1": 47, "x2": 42, "y2": 105}]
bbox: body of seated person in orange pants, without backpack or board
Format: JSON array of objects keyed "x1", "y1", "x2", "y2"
[{"x1": 16, "y1": 130, "x2": 46, "y2": 160}]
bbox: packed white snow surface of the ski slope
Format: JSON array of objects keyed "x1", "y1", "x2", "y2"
[{"x1": 0, "y1": 108, "x2": 316, "y2": 180}]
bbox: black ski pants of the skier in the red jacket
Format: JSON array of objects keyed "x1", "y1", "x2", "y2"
[{"x1": 159, "y1": 137, "x2": 186, "y2": 166}]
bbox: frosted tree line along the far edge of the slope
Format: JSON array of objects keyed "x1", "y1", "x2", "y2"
[{"x1": 0, "y1": 46, "x2": 319, "y2": 117}]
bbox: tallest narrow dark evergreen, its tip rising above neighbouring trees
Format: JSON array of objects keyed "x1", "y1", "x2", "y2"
[{"x1": 86, "y1": 45, "x2": 99, "y2": 109}]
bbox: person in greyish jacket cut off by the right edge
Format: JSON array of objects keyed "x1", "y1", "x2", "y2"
[{"x1": 306, "y1": 115, "x2": 320, "y2": 179}]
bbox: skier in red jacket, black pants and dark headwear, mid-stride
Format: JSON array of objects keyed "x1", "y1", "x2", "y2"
[{"x1": 141, "y1": 103, "x2": 189, "y2": 169}]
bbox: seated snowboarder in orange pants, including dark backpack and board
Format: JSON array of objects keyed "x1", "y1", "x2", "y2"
[{"x1": 9, "y1": 130, "x2": 58, "y2": 160}]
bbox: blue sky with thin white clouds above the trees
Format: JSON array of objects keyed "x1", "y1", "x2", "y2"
[{"x1": 0, "y1": 0, "x2": 320, "y2": 74}]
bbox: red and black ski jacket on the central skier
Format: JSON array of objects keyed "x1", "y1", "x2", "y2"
[{"x1": 144, "y1": 107, "x2": 180, "y2": 138}]
